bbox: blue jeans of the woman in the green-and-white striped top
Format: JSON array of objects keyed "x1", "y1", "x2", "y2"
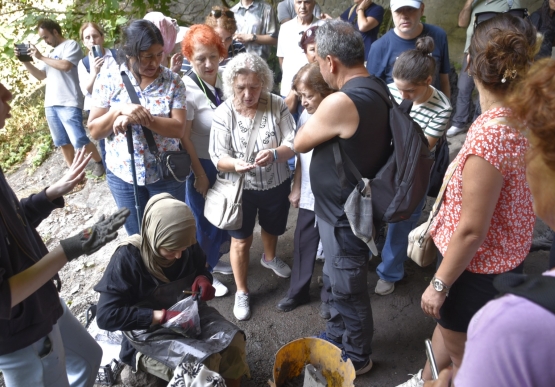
[{"x1": 376, "y1": 196, "x2": 426, "y2": 282}]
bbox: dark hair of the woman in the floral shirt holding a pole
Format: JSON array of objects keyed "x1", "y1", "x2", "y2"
[{"x1": 118, "y1": 19, "x2": 164, "y2": 83}]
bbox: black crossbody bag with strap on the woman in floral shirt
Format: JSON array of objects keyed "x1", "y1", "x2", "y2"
[{"x1": 121, "y1": 71, "x2": 191, "y2": 183}]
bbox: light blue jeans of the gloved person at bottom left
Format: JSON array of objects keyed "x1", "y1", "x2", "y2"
[{"x1": 0, "y1": 300, "x2": 102, "y2": 387}]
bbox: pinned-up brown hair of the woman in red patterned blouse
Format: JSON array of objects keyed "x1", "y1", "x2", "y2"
[{"x1": 467, "y1": 13, "x2": 541, "y2": 92}]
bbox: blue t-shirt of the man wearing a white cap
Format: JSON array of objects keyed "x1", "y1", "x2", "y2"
[{"x1": 366, "y1": 23, "x2": 451, "y2": 90}]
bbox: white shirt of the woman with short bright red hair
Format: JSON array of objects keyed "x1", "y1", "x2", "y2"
[{"x1": 183, "y1": 69, "x2": 223, "y2": 160}]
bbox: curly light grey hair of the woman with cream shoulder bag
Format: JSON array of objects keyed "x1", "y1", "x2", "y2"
[{"x1": 223, "y1": 52, "x2": 274, "y2": 98}]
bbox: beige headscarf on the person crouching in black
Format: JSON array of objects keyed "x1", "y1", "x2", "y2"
[{"x1": 120, "y1": 193, "x2": 197, "y2": 283}]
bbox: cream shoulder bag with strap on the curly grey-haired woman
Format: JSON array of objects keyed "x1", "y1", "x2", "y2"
[{"x1": 204, "y1": 94, "x2": 269, "y2": 230}]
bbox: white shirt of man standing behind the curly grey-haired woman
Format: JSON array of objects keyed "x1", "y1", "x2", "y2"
[{"x1": 277, "y1": 17, "x2": 322, "y2": 97}]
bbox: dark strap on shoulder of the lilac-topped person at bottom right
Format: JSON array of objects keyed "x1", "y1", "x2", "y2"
[{"x1": 493, "y1": 273, "x2": 555, "y2": 313}]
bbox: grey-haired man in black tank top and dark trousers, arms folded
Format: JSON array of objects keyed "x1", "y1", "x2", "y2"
[{"x1": 295, "y1": 20, "x2": 391, "y2": 375}]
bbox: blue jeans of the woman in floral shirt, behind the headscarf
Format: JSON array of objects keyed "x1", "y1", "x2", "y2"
[{"x1": 106, "y1": 169, "x2": 185, "y2": 235}]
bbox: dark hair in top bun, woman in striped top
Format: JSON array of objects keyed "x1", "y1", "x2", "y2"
[{"x1": 393, "y1": 36, "x2": 436, "y2": 85}]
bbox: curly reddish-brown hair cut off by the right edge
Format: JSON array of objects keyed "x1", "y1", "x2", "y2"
[{"x1": 507, "y1": 59, "x2": 555, "y2": 172}]
